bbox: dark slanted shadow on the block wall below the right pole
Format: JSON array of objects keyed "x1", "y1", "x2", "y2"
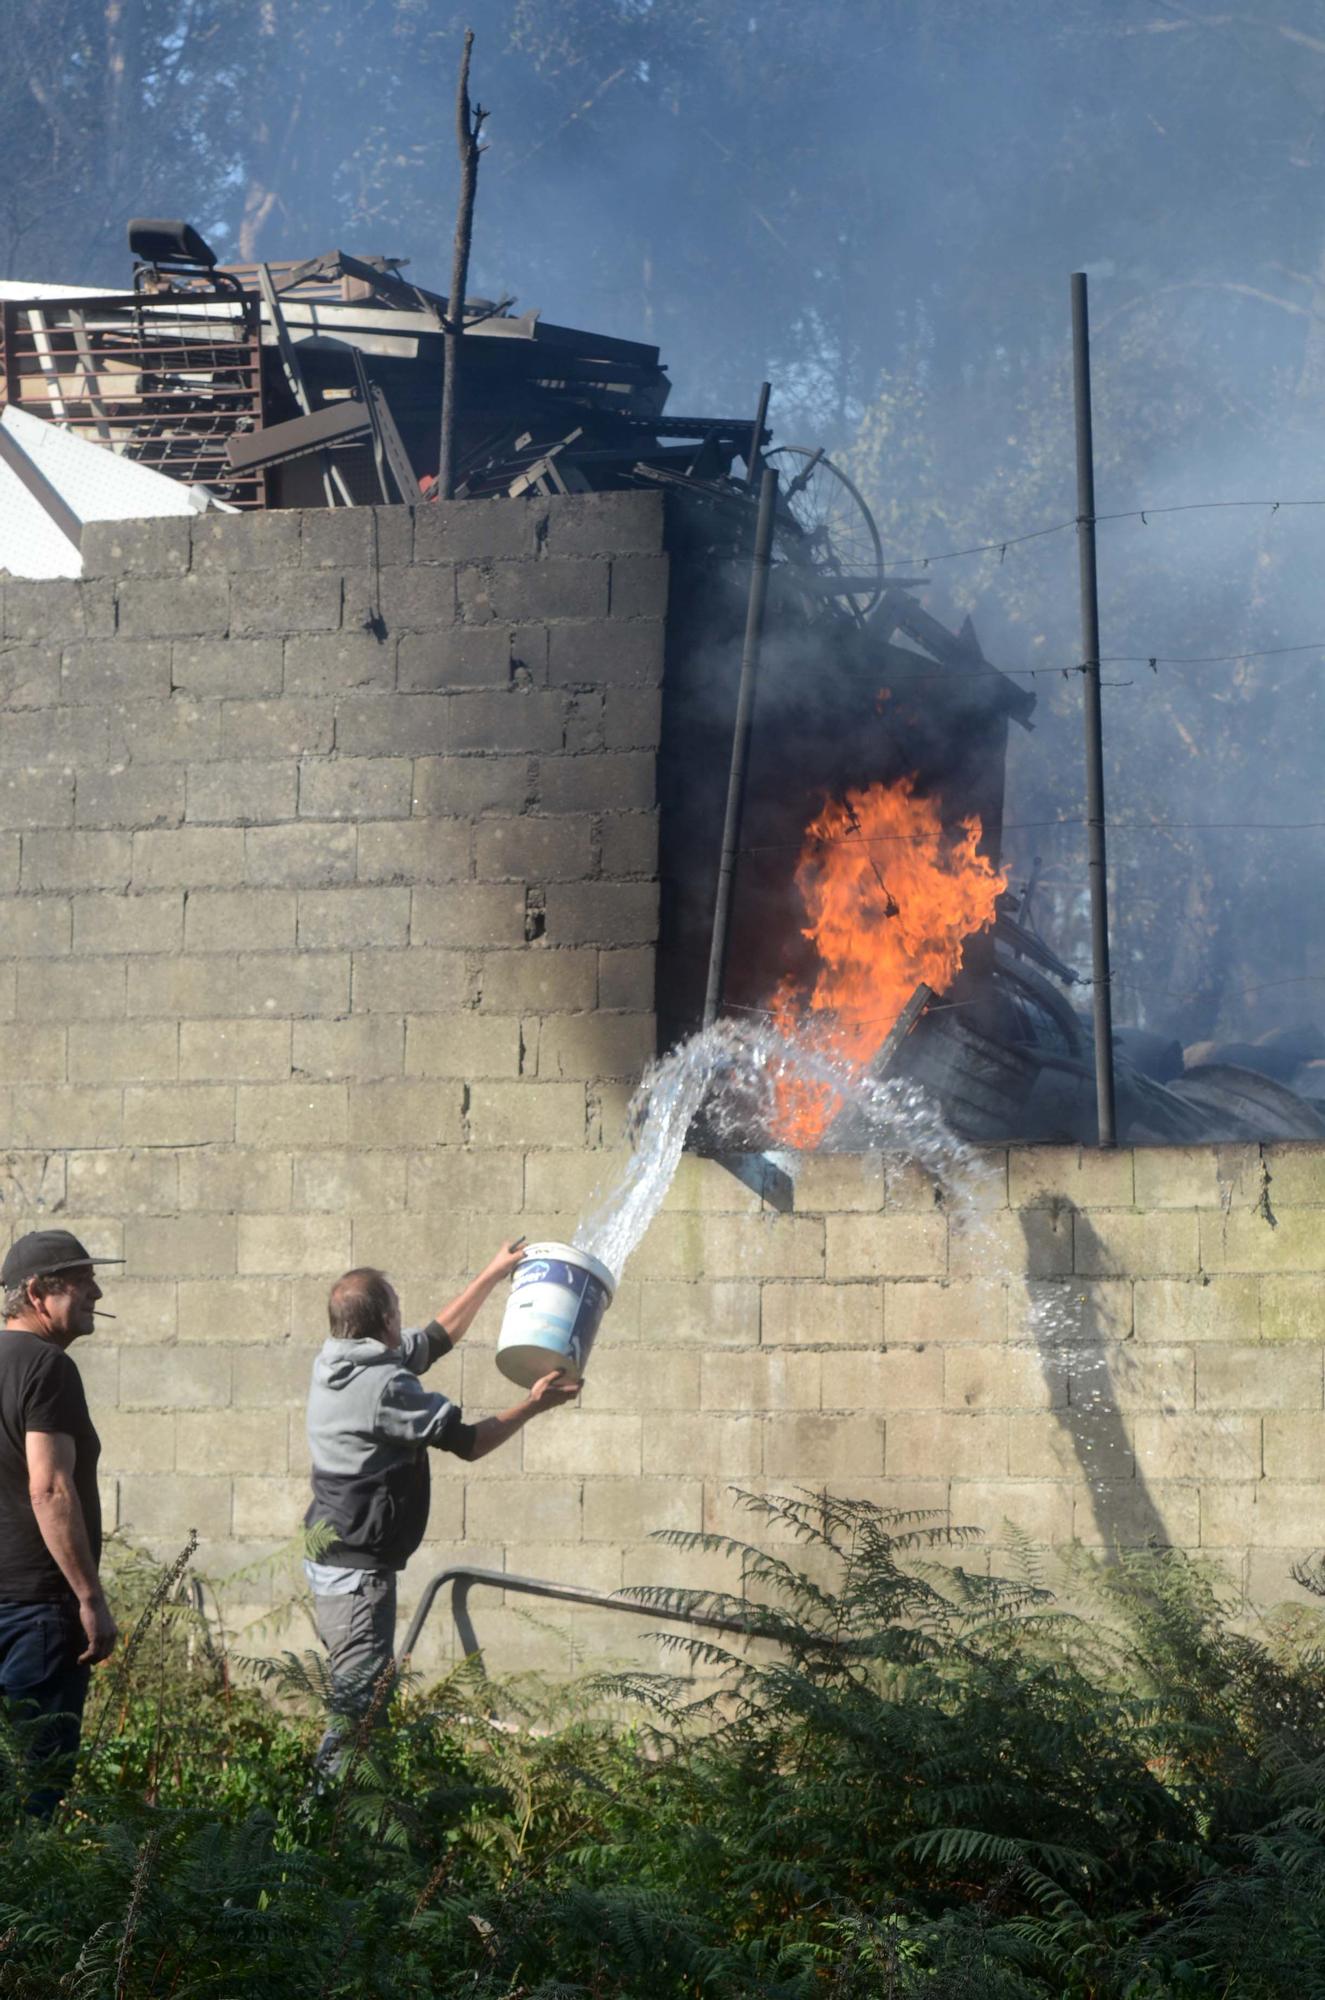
[{"x1": 1023, "y1": 1202, "x2": 1171, "y2": 1554}]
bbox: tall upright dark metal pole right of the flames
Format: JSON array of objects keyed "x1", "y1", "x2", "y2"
[{"x1": 1073, "y1": 270, "x2": 1117, "y2": 1146}]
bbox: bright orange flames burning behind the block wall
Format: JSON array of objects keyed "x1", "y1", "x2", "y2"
[{"x1": 773, "y1": 778, "x2": 1007, "y2": 1146}]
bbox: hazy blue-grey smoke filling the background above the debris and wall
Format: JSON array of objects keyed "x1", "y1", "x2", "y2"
[{"x1": 0, "y1": 0, "x2": 1325, "y2": 1042}]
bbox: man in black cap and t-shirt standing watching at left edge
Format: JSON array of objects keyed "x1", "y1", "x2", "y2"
[{"x1": 0, "y1": 1230, "x2": 124, "y2": 1818}]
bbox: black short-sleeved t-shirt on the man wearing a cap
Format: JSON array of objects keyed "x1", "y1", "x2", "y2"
[{"x1": 0, "y1": 1326, "x2": 102, "y2": 1604}]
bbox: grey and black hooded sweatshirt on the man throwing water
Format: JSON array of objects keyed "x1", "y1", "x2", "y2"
[{"x1": 304, "y1": 1320, "x2": 474, "y2": 1570}]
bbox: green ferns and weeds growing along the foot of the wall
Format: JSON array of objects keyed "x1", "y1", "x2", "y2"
[{"x1": 0, "y1": 1496, "x2": 1325, "y2": 2000}]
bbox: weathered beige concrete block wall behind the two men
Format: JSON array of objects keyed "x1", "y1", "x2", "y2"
[{"x1": 0, "y1": 494, "x2": 1325, "y2": 1668}]
